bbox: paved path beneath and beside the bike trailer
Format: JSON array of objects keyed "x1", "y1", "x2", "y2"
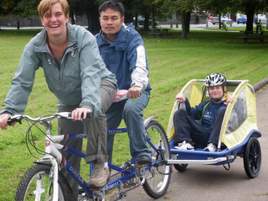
[{"x1": 126, "y1": 86, "x2": 268, "y2": 201}]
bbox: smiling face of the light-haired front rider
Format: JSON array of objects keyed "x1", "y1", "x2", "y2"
[{"x1": 41, "y1": 3, "x2": 69, "y2": 38}]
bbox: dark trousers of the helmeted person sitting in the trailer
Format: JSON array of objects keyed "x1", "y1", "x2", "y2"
[{"x1": 173, "y1": 107, "x2": 226, "y2": 148}]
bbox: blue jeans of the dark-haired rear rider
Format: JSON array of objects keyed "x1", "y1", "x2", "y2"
[{"x1": 106, "y1": 92, "x2": 151, "y2": 161}]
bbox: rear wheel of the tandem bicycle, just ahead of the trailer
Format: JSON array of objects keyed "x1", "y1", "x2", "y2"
[{"x1": 143, "y1": 120, "x2": 171, "y2": 198}]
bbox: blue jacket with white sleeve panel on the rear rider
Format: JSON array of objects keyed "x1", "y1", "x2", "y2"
[{"x1": 96, "y1": 25, "x2": 150, "y2": 90}]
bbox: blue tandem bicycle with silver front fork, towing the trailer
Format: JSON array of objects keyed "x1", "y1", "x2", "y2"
[{"x1": 9, "y1": 112, "x2": 171, "y2": 201}]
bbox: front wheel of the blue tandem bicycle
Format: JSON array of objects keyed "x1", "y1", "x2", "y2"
[{"x1": 15, "y1": 164, "x2": 74, "y2": 201}]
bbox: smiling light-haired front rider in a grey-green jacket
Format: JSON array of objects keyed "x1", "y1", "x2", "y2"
[{"x1": 0, "y1": 0, "x2": 117, "y2": 198}]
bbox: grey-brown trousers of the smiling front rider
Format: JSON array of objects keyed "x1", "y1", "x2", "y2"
[{"x1": 58, "y1": 80, "x2": 116, "y2": 200}]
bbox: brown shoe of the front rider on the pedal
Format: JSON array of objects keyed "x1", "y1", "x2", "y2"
[{"x1": 89, "y1": 163, "x2": 110, "y2": 188}]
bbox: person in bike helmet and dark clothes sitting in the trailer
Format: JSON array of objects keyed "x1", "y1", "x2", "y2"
[{"x1": 173, "y1": 73, "x2": 229, "y2": 152}]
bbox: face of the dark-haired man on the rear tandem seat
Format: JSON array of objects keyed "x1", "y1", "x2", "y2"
[{"x1": 100, "y1": 8, "x2": 124, "y2": 40}]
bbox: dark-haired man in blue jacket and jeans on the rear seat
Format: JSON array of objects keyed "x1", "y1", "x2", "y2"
[{"x1": 96, "y1": 1, "x2": 151, "y2": 165}]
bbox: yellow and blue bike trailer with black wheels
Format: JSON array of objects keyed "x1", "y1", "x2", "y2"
[{"x1": 166, "y1": 79, "x2": 261, "y2": 178}]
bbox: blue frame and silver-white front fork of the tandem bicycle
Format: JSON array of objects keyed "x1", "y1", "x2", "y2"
[{"x1": 46, "y1": 128, "x2": 146, "y2": 198}]
